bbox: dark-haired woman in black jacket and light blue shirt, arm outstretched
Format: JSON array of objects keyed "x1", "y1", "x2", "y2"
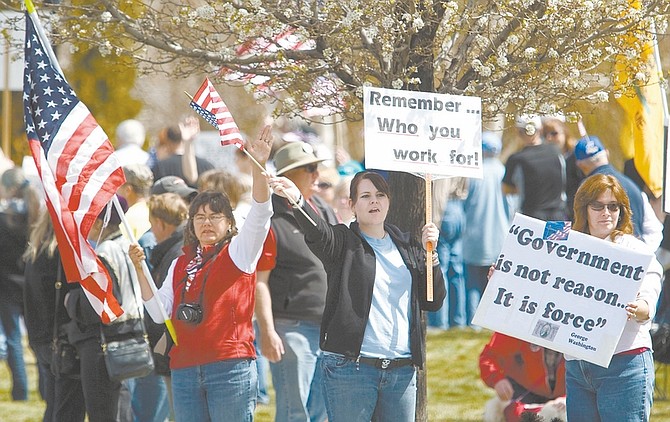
[{"x1": 271, "y1": 171, "x2": 446, "y2": 422}]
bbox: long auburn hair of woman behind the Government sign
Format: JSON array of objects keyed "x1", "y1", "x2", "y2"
[{"x1": 572, "y1": 174, "x2": 633, "y2": 240}]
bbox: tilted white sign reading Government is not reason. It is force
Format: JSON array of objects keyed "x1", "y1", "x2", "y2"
[{"x1": 472, "y1": 214, "x2": 653, "y2": 367}]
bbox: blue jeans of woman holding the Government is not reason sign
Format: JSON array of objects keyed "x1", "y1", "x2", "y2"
[{"x1": 565, "y1": 350, "x2": 654, "y2": 422}]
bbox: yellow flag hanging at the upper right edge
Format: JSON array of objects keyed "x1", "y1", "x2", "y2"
[{"x1": 616, "y1": 9, "x2": 665, "y2": 198}]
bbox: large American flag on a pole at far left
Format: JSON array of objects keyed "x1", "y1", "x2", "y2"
[{"x1": 23, "y1": 12, "x2": 125, "y2": 323}]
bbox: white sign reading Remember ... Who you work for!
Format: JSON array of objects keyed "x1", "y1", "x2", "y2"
[{"x1": 363, "y1": 86, "x2": 483, "y2": 179}]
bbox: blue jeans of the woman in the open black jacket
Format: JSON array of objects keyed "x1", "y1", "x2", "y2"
[{"x1": 320, "y1": 352, "x2": 416, "y2": 422}]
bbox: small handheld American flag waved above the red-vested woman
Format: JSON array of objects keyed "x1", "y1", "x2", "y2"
[{"x1": 190, "y1": 78, "x2": 244, "y2": 148}]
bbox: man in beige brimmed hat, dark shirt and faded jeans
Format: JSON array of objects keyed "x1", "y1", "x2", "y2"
[{"x1": 256, "y1": 142, "x2": 337, "y2": 422}]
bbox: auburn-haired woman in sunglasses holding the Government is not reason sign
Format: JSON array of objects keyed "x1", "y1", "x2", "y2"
[{"x1": 565, "y1": 174, "x2": 663, "y2": 422}]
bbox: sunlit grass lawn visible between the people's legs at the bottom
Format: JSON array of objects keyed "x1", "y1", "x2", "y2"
[{"x1": 0, "y1": 331, "x2": 670, "y2": 422}]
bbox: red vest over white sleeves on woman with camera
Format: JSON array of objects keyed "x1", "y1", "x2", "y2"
[{"x1": 170, "y1": 245, "x2": 256, "y2": 369}]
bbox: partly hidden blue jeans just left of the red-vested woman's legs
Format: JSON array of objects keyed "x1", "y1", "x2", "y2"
[{"x1": 127, "y1": 373, "x2": 170, "y2": 422}]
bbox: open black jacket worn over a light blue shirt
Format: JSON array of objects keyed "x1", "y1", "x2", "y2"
[{"x1": 294, "y1": 199, "x2": 446, "y2": 368}]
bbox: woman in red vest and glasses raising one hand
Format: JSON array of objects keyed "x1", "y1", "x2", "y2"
[{"x1": 130, "y1": 126, "x2": 272, "y2": 422}]
